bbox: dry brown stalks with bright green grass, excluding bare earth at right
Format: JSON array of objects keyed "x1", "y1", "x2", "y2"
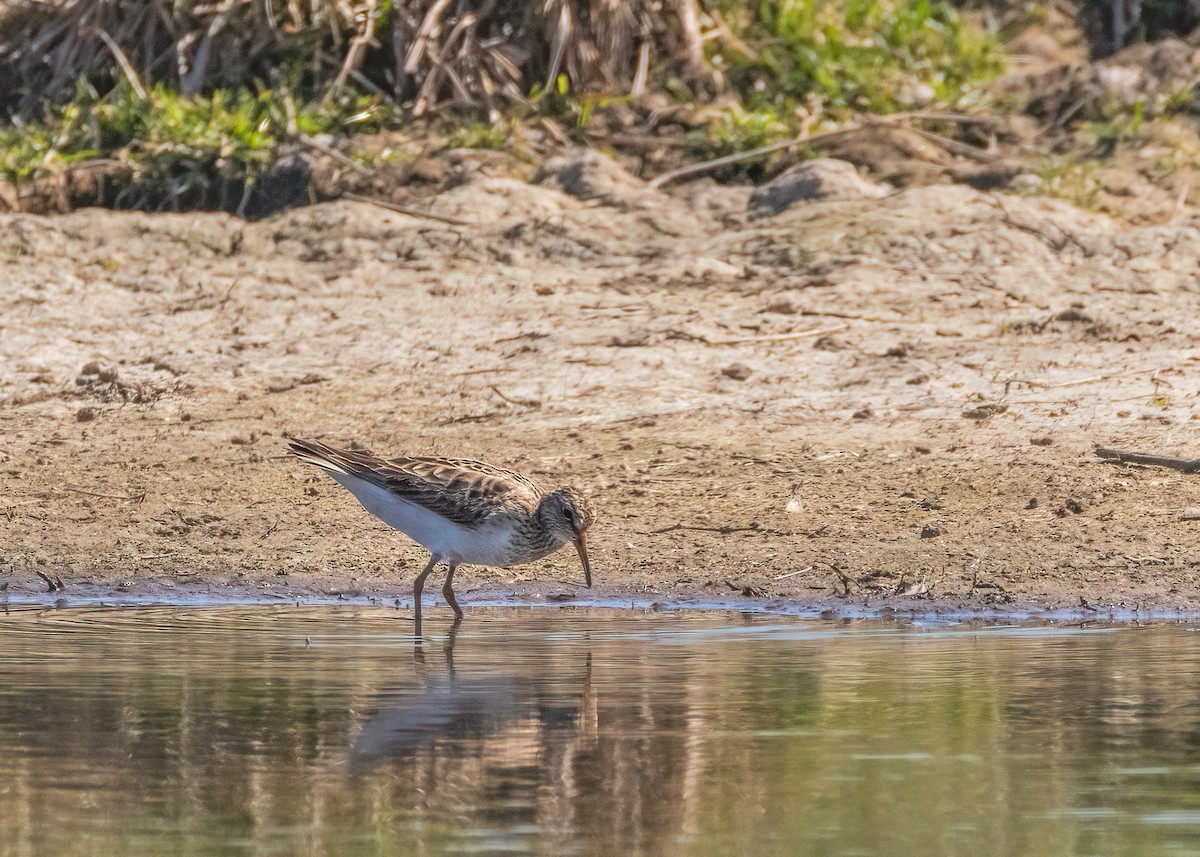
[{"x1": 0, "y1": 0, "x2": 1002, "y2": 214}]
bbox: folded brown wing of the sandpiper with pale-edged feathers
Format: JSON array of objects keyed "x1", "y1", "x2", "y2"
[{"x1": 289, "y1": 438, "x2": 541, "y2": 526}]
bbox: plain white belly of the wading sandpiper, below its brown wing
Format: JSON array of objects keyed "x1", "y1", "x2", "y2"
[{"x1": 329, "y1": 473, "x2": 511, "y2": 565}]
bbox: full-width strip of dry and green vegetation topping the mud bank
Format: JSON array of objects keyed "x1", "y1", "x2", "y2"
[{"x1": 0, "y1": 0, "x2": 1200, "y2": 217}]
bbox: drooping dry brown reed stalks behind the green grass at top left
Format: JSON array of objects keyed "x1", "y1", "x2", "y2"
[{"x1": 0, "y1": 0, "x2": 704, "y2": 116}]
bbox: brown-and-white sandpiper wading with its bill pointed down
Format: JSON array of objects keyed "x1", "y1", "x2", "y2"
[{"x1": 287, "y1": 437, "x2": 595, "y2": 636}]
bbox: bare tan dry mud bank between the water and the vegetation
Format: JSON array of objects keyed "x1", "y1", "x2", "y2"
[{"x1": 0, "y1": 157, "x2": 1200, "y2": 615}]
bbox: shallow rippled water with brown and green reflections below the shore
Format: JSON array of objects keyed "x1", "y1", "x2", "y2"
[{"x1": 0, "y1": 606, "x2": 1200, "y2": 857}]
